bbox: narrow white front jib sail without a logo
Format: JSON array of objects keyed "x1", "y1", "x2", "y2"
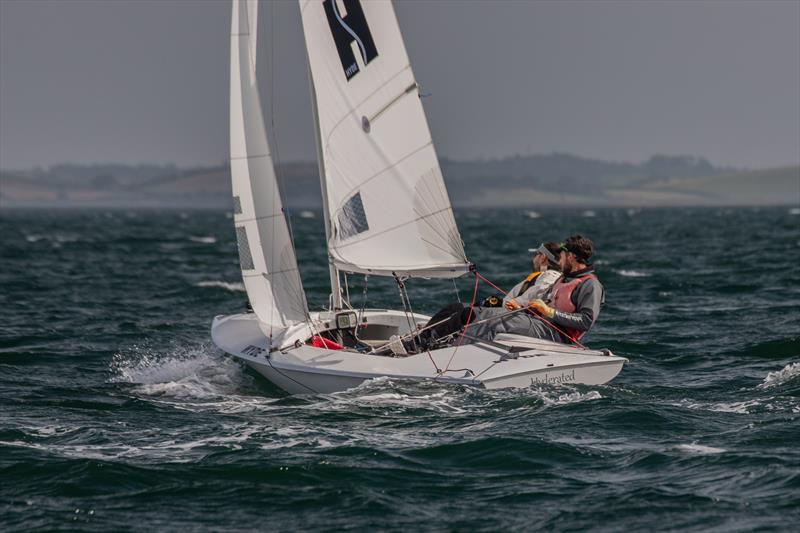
[{"x1": 230, "y1": 0, "x2": 308, "y2": 335}]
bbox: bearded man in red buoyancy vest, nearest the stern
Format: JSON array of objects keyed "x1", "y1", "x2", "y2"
[{"x1": 467, "y1": 235, "x2": 605, "y2": 343}]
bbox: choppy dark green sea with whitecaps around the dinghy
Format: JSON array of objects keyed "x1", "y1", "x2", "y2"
[{"x1": 0, "y1": 207, "x2": 800, "y2": 532}]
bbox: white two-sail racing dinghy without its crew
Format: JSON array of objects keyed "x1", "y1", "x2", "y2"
[{"x1": 211, "y1": 0, "x2": 626, "y2": 394}]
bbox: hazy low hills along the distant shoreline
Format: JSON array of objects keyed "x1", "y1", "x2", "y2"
[{"x1": 0, "y1": 153, "x2": 800, "y2": 209}]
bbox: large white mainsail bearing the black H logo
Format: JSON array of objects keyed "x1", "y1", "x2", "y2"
[{"x1": 299, "y1": 0, "x2": 469, "y2": 277}]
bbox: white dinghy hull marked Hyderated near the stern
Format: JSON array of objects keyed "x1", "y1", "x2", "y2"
[{"x1": 211, "y1": 311, "x2": 627, "y2": 394}]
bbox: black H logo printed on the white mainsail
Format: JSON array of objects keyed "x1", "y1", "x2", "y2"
[{"x1": 322, "y1": 0, "x2": 378, "y2": 81}]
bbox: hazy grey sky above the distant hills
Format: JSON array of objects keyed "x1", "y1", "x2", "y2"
[{"x1": 0, "y1": 0, "x2": 800, "y2": 169}]
